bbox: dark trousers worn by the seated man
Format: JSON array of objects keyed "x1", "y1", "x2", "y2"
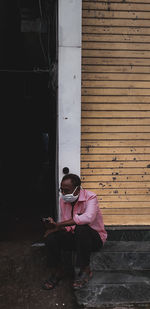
[{"x1": 45, "y1": 225, "x2": 103, "y2": 267}]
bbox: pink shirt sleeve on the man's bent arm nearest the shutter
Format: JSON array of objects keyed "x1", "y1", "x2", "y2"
[{"x1": 73, "y1": 195, "x2": 99, "y2": 225}]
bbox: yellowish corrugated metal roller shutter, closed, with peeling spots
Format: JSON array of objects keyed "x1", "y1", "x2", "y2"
[{"x1": 81, "y1": 0, "x2": 150, "y2": 225}]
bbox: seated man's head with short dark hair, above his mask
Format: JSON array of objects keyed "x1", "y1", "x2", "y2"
[{"x1": 60, "y1": 174, "x2": 81, "y2": 195}]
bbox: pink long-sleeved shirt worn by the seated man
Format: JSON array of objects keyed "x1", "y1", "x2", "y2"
[{"x1": 60, "y1": 189, "x2": 107, "y2": 243}]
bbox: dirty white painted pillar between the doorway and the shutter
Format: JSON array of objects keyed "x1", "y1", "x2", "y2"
[{"x1": 58, "y1": 0, "x2": 82, "y2": 184}]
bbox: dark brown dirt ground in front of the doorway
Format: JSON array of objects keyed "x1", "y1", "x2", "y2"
[{"x1": 0, "y1": 242, "x2": 78, "y2": 309}]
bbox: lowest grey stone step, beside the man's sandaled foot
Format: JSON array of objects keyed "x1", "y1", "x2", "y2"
[{"x1": 75, "y1": 271, "x2": 150, "y2": 308}]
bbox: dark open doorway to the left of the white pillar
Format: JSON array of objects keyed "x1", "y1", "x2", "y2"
[{"x1": 0, "y1": 0, "x2": 57, "y2": 240}]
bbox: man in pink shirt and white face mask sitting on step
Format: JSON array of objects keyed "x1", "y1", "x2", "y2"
[{"x1": 43, "y1": 174, "x2": 107, "y2": 290}]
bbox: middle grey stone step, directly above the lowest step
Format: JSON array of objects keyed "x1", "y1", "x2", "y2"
[{"x1": 91, "y1": 241, "x2": 150, "y2": 271}]
